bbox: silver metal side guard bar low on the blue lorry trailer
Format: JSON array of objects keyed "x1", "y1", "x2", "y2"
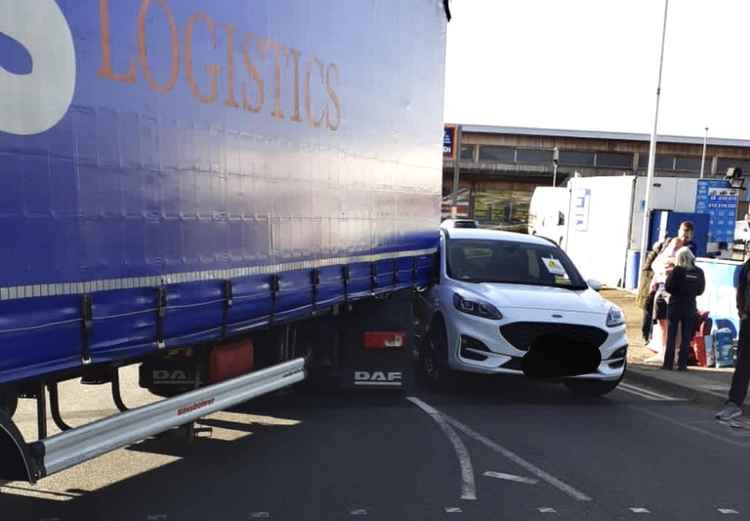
[{"x1": 31, "y1": 358, "x2": 305, "y2": 478}]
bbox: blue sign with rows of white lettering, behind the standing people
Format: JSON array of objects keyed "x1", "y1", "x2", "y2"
[{"x1": 695, "y1": 179, "x2": 739, "y2": 243}]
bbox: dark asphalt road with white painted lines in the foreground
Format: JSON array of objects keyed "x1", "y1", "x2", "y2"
[{"x1": 0, "y1": 368, "x2": 750, "y2": 521}]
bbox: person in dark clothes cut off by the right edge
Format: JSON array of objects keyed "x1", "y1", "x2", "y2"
[{"x1": 716, "y1": 260, "x2": 750, "y2": 421}]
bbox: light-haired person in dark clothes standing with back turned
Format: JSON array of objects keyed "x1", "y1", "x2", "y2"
[{"x1": 662, "y1": 246, "x2": 706, "y2": 371}]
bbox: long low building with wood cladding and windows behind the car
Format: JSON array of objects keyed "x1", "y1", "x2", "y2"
[{"x1": 443, "y1": 125, "x2": 750, "y2": 226}]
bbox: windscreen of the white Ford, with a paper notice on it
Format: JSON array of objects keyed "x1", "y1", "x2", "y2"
[{"x1": 447, "y1": 239, "x2": 587, "y2": 289}]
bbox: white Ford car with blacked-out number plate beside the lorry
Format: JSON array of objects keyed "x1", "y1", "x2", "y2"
[{"x1": 417, "y1": 229, "x2": 628, "y2": 395}]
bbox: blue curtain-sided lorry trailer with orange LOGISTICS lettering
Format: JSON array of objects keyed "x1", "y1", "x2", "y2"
[{"x1": 0, "y1": 0, "x2": 449, "y2": 482}]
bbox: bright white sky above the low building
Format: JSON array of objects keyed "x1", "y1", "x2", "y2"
[{"x1": 445, "y1": 0, "x2": 750, "y2": 139}]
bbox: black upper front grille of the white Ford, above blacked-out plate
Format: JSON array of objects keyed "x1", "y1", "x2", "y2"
[{"x1": 500, "y1": 322, "x2": 607, "y2": 351}]
